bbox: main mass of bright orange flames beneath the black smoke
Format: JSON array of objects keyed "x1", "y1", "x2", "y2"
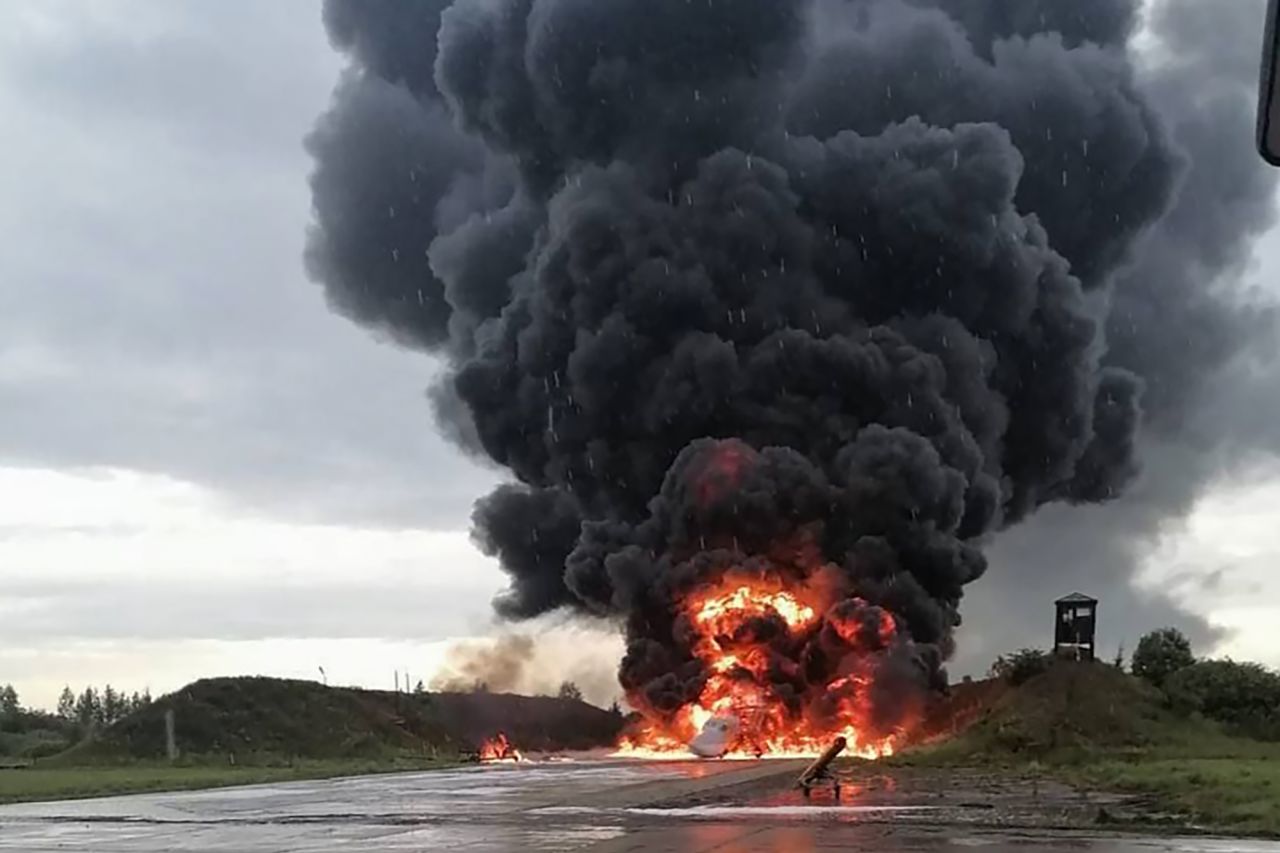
[{"x1": 618, "y1": 563, "x2": 897, "y2": 758}]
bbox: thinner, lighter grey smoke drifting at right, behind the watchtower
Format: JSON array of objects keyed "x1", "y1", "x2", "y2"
[{"x1": 961, "y1": 0, "x2": 1280, "y2": 667}]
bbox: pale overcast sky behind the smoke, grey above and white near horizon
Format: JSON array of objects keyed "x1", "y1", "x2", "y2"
[{"x1": 0, "y1": 0, "x2": 1280, "y2": 704}]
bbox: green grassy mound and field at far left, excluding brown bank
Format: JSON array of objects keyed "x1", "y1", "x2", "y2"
[{"x1": 0, "y1": 679, "x2": 483, "y2": 803}]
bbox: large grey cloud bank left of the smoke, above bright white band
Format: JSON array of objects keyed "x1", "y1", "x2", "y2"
[{"x1": 0, "y1": 3, "x2": 497, "y2": 528}]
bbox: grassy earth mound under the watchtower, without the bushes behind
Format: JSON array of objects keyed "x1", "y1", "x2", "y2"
[{"x1": 884, "y1": 663, "x2": 1280, "y2": 836}]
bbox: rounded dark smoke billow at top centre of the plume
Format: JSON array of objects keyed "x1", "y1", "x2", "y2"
[{"x1": 436, "y1": 0, "x2": 805, "y2": 191}]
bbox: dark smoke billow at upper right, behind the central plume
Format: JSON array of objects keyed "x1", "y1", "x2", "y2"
[{"x1": 791, "y1": 0, "x2": 1179, "y2": 289}]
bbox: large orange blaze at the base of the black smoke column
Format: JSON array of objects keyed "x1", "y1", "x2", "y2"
[{"x1": 611, "y1": 502, "x2": 918, "y2": 758}]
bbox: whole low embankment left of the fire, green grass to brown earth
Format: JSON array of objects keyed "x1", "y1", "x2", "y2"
[{"x1": 0, "y1": 678, "x2": 622, "y2": 803}]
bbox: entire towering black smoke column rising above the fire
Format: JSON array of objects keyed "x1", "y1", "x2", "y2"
[{"x1": 307, "y1": 0, "x2": 1272, "y2": 707}]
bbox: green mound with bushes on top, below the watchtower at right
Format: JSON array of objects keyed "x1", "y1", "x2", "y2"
[{"x1": 892, "y1": 629, "x2": 1280, "y2": 836}]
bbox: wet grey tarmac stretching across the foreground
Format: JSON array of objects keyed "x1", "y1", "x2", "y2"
[{"x1": 0, "y1": 762, "x2": 1280, "y2": 853}]
